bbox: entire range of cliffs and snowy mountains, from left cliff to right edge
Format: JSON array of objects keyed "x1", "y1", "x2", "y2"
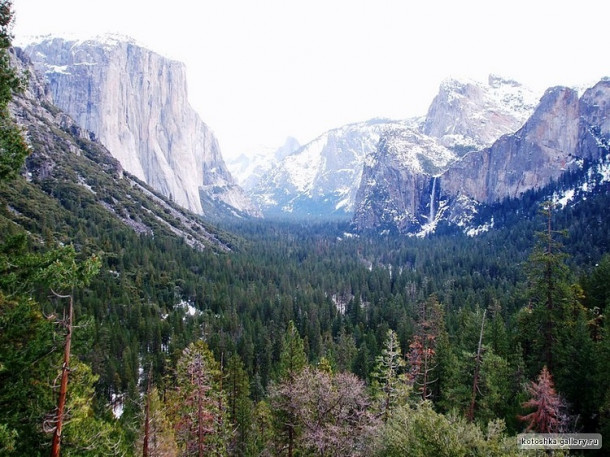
[{"x1": 19, "y1": 36, "x2": 610, "y2": 235}]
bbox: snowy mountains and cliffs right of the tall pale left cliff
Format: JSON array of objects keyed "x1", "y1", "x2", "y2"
[{"x1": 238, "y1": 76, "x2": 610, "y2": 235}]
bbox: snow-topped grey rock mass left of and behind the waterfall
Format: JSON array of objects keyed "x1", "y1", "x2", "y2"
[{"x1": 353, "y1": 76, "x2": 536, "y2": 232}]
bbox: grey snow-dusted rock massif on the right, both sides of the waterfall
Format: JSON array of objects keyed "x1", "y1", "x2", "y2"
[{"x1": 353, "y1": 79, "x2": 610, "y2": 232}]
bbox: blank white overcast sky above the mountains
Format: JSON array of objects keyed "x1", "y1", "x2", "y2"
[{"x1": 13, "y1": 0, "x2": 610, "y2": 158}]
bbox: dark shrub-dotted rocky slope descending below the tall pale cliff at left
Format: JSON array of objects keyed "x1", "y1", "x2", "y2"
[{"x1": 8, "y1": 48, "x2": 230, "y2": 251}]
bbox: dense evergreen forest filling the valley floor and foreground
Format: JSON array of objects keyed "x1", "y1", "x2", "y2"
[{"x1": 0, "y1": 2, "x2": 610, "y2": 457}]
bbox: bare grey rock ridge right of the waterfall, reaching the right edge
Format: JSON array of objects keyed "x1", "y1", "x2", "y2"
[{"x1": 442, "y1": 81, "x2": 610, "y2": 203}]
